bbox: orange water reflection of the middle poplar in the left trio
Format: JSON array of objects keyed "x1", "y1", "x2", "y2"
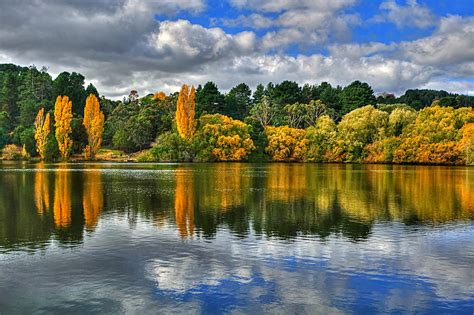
[{"x1": 54, "y1": 169, "x2": 71, "y2": 228}]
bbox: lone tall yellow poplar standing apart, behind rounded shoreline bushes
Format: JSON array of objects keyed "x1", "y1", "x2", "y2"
[{"x1": 176, "y1": 84, "x2": 196, "y2": 139}]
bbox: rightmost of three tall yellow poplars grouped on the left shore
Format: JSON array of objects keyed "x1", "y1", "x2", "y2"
[{"x1": 83, "y1": 94, "x2": 104, "y2": 160}]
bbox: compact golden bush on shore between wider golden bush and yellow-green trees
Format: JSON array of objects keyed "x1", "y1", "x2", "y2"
[{"x1": 265, "y1": 126, "x2": 308, "y2": 161}]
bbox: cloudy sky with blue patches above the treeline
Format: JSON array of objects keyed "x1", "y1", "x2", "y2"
[{"x1": 0, "y1": 0, "x2": 474, "y2": 98}]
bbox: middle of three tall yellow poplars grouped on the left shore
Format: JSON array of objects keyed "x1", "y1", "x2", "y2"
[{"x1": 54, "y1": 96, "x2": 72, "y2": 160}]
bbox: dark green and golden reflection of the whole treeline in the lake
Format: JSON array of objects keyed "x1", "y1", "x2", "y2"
[{"x1": 0, "y1": 163, "x2": 474, "y2": 248}]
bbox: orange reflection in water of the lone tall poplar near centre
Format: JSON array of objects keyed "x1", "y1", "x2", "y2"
[{"x1": 174, "y1": 170, "x2": 194, "y2": 238}]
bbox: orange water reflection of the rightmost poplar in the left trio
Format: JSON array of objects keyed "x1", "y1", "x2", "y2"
[{"x1": 82, "y1": 170, "x2": 104, "y2": 229}]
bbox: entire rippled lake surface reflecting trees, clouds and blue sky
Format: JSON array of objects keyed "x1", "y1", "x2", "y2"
[{"x1": 0, "y1": 162, "x2": 474, "y2": 314}]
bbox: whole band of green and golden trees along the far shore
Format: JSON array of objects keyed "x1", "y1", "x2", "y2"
[{"x1": 0, "y1": 64, "x2": 474, "y2": 165}]
